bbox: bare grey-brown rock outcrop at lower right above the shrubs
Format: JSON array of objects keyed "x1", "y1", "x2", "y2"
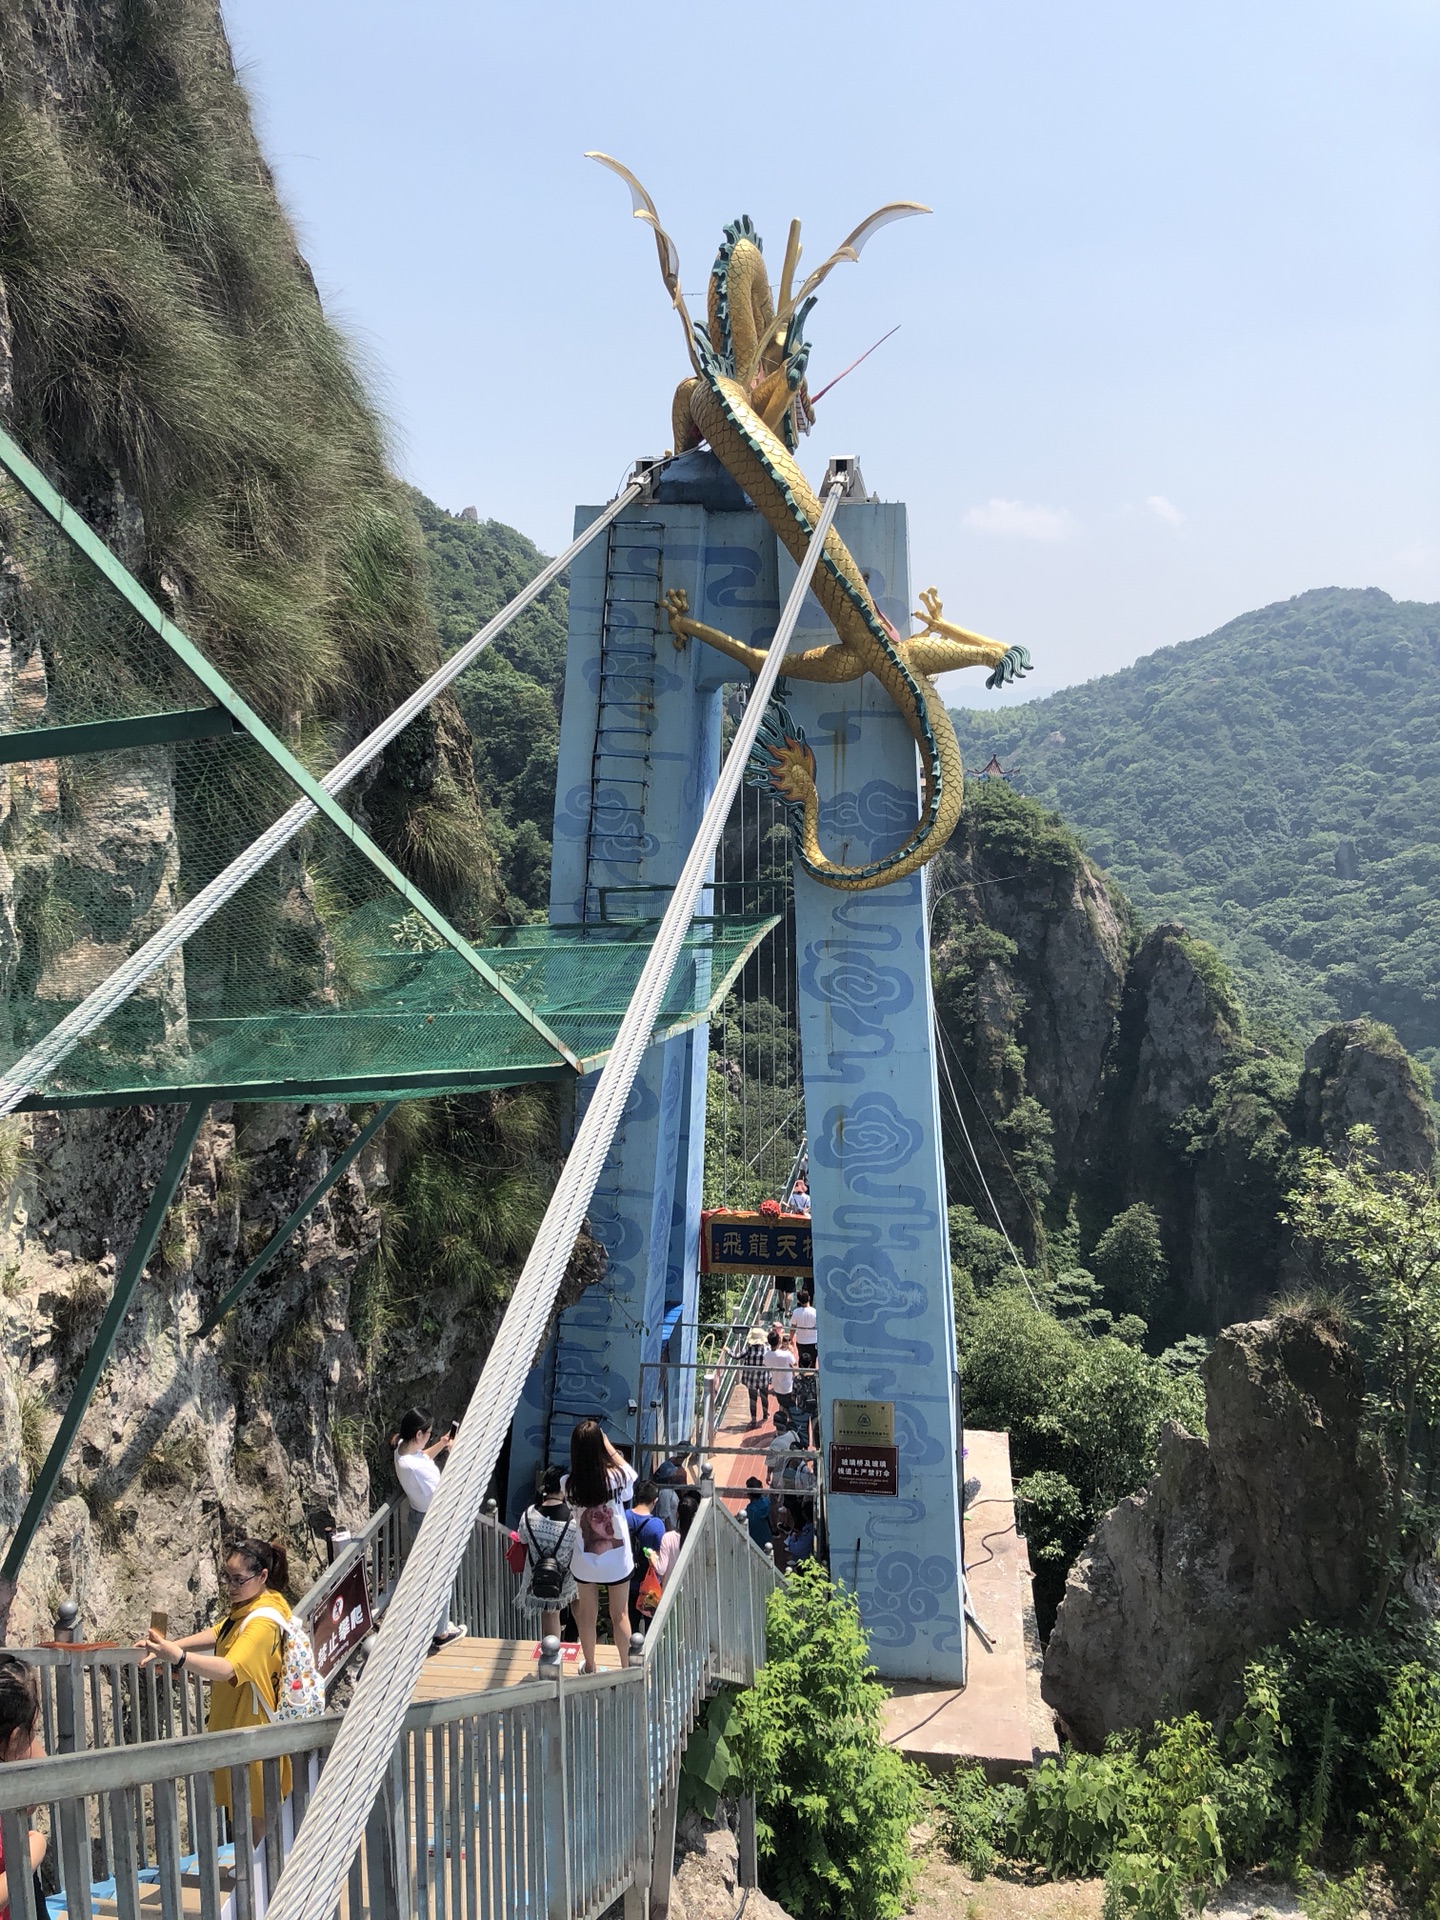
[{"x1": 1043, "y1": 1315, "x2": 1384, "y2": 1747}]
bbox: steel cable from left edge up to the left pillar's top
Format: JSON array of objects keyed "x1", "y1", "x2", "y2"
[{"x1": 0, "y1": 480, "x2": 643, "y2": 1114}]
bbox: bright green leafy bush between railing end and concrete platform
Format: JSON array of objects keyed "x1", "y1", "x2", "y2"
[{"x1": 726, "y1": 1563, "x2": 920, "y2": 1920}]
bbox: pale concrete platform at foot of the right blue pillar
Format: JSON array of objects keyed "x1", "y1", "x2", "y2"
[{"x1": 885, "y1": 1428, "x2": 1056, "y2": 1780}]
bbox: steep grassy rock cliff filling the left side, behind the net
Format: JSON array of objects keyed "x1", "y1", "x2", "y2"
[{"x1": 0, "y1": 0, "x2": 557, "y2": 1636}]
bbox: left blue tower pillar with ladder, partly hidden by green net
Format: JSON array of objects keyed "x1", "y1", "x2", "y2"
[{"x1": 509, "y1": 455, "x2": 778, "y2": 1511}]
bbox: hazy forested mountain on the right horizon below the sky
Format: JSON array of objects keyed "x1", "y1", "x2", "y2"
[{"x1": 954, "y1": 588, "x2": 1440, "y2": 1062}]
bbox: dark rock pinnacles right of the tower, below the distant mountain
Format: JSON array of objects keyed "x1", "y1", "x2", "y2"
[{"x1": 935, "y1": 780, "x2": 1434, "y2": 1340}]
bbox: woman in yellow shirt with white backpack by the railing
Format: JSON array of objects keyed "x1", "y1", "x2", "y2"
[{"x1": 138, "y1": 1540, "x2": 290, "y2": 1841}]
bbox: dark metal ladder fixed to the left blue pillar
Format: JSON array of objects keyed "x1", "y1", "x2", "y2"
[{"x1": 584, "y1": 520, "x2": 664, "y2": 922}]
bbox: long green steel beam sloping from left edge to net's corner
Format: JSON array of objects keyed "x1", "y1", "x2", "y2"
[{"x1": 0, "y1": 428, "x2": 580, "y2": 1073}]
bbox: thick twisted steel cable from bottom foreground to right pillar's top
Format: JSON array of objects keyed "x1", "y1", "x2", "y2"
[{"x1": 269, "y1": 476, "x2": 841, "y2": 1920}]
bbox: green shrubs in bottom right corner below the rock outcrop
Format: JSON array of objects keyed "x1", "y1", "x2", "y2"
[{"x1": 933, "y1": 1628, "x2": 1440, "y2": 1920}]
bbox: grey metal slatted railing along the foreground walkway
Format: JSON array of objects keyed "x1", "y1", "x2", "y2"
[{"x1": 0, "y1": 1500, "x2": 776, "y2": 1920}]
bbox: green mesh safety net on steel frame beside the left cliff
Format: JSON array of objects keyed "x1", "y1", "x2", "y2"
[{"x1": 0, "y1": 460, "x2": 774, "y2": 1108}]
